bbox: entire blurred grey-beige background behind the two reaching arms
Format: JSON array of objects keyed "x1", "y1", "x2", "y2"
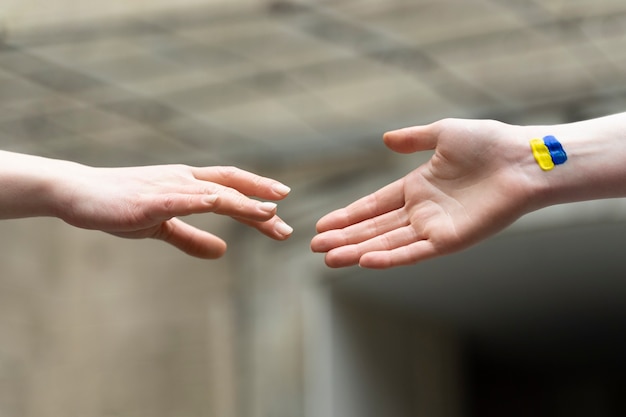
[{"x1": 0, "y1": 0, "x2": 626, "y2": 417}]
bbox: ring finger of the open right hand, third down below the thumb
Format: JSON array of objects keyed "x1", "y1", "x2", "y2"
[{"x1": 325, "y1": 226, "x2": 421, "y2": 268}]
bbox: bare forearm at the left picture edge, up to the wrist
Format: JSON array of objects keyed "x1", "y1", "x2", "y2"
[{"x1": 0, "y1": 151, "x2": 77, "y2": 219}]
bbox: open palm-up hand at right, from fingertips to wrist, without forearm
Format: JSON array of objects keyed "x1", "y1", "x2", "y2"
[{"x1": 311, "y1": 119, "x2": 532, "y2": 268}]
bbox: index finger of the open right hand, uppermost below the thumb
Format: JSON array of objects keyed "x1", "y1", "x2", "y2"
[{"x1": 315, "y1": 180, "x2": 404, "y2": 233}]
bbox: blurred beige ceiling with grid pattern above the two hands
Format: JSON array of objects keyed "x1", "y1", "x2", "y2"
[{"x1": 0, "y1": 0, "x2": 626, "y2": 165}]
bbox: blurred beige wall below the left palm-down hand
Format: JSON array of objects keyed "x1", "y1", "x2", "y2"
[{"x1": 0, "y1": 219, "x2": 236, "y2": 417}]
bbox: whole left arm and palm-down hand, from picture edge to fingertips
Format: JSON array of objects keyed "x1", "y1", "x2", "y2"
[{"x1": 0, "y1": 152, "x2": 292, "y2": 259}]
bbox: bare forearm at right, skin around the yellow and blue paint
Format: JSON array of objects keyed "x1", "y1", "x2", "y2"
[{"x1": 521, "y1": 113, "x2": 626, "y2": 208}]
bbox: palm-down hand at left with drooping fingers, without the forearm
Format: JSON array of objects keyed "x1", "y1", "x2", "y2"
[{"x1": 54, "y1": 164, "x2": 292, "y2": 258}]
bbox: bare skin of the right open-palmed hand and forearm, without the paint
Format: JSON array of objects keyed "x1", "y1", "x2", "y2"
[{"x1": 311, "y1": 113, "x2": 626, "y2": 269}]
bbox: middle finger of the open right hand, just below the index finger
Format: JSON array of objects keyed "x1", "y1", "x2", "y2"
[{"x1": 311, "y1": 209, "x2": 409, "y2": 252}]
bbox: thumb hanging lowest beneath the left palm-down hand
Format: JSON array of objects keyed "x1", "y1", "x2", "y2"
[{"x1": 153, "y1": 218, "x2": 226, "y2": 259}]
